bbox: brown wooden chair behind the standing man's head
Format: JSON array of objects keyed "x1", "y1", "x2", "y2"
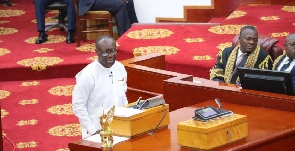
[{"x1": 73, "y1": 0, "x2": 114, "y2": 47}]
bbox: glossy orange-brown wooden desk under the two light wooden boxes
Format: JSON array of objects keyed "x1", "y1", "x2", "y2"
[{"x1": 69, "y1": 100, "x2": 295, "y2": 151}]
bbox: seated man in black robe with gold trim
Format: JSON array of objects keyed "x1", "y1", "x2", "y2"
[{"x1": 210, "y1": 26, "x2": 272, "y2": 84}]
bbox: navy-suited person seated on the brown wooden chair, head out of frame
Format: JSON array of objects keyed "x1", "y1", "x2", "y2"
[{"x1": 78, "y1": 0, "x2": 138, "y2": 37}]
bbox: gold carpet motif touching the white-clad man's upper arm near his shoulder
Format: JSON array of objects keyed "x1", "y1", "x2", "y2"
[{"x1": 48, "y1": 85, "x2": 75, "y2": 96}]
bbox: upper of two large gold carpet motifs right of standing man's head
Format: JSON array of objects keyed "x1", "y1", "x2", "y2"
[{"x1": 127, "y1": 29, "x2": 174, "y2": 39}]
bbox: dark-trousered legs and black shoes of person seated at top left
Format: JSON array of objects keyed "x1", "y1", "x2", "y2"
[{"x1": 35, "y1": 0, "x2": 76, "y2": 44}]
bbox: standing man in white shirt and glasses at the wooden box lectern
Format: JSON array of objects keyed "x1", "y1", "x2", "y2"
[{"x1": 72, "y1": 35, "x2": 128, "y2": 138}]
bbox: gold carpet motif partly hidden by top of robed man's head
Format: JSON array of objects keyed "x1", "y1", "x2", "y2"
[{"x1": 208, "y1": 25, "x2": 249, "y2": 34}]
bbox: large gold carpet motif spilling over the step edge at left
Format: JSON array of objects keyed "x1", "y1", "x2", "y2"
[{"x1": 17, "y1": 57, "x2": 63, "y2": 71}]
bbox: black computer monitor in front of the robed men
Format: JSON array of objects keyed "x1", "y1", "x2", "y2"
[{"x1": 238, "y1": 67, "x2": 294, "y2": 95}]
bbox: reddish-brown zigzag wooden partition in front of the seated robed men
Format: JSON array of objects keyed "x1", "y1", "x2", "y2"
[{"x1": 123, "y1": 54, "x2": 295, "y2": 112}]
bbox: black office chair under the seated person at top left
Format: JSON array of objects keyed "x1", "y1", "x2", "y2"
[{"x1": 45, "y1": 0, "x2": 68, "y2": 31}]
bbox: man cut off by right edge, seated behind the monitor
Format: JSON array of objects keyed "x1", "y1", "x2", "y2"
[{"x1": 273, "y1": 33, "x2": 295, "y2": 71}]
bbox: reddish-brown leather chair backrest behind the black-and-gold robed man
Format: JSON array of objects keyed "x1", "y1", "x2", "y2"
[{"x1": 232, "y1": 34, "x2": 283, "y2": 60}]
